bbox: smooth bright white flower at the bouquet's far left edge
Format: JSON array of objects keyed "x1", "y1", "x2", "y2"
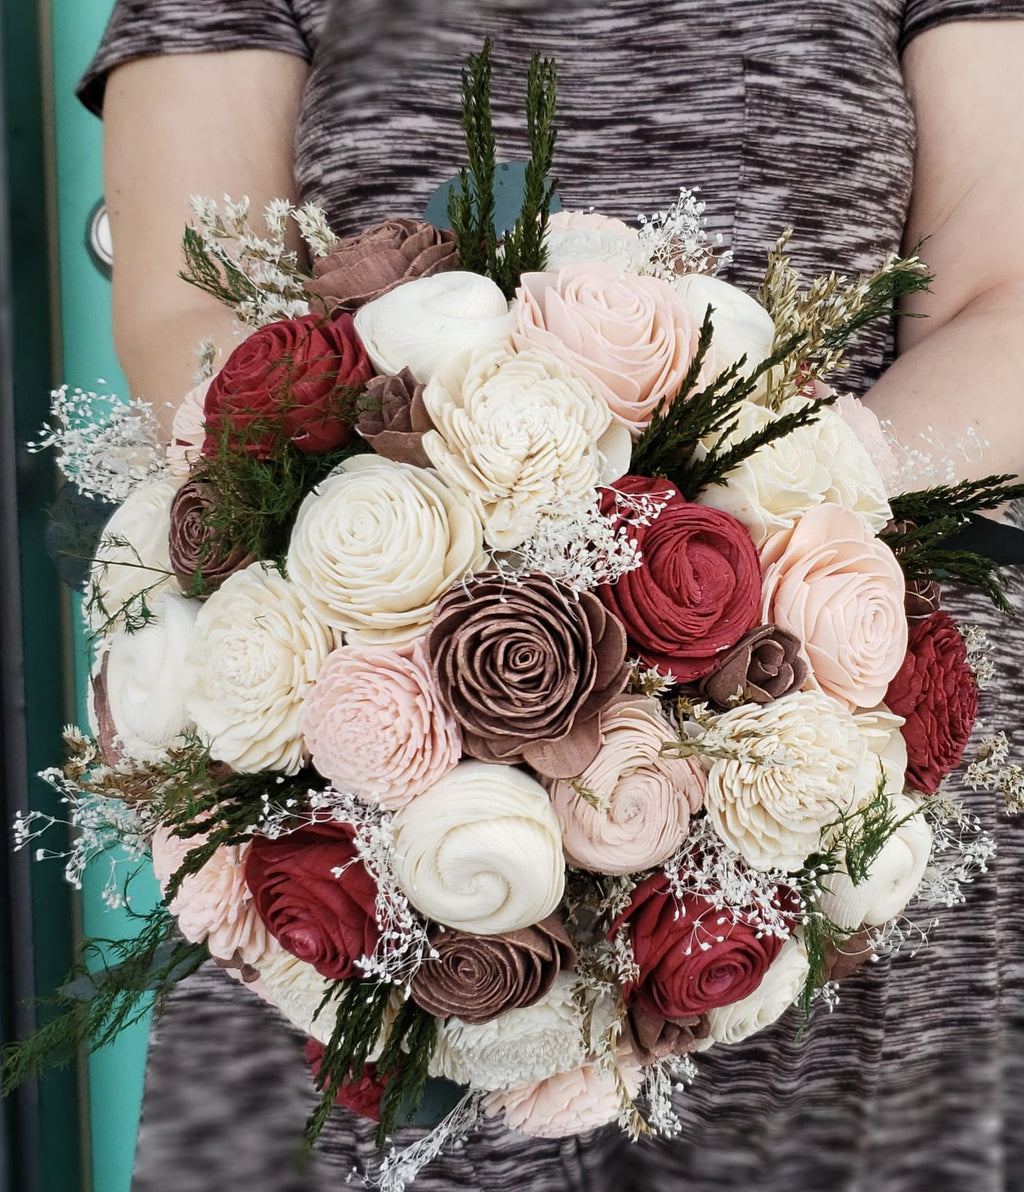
[{"x1": 106, "y1": 592, "x2": 200, "y2": 762}]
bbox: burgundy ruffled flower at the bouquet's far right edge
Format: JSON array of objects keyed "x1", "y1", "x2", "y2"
[{"x1": 886, "y1": 610, "x2": 978, "y2": 795}]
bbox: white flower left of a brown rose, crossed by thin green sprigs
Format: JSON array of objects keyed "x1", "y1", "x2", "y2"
[{"x1": 88, "y1": 479, "x2": 181, "y2": 632}]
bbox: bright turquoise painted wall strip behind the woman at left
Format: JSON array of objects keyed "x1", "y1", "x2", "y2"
[{"x1": 51, "y1": 0, "x2": 155, "y2": 1192}]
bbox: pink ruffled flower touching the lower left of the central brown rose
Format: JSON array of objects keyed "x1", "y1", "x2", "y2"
[{"x1": 302, "y1": 641, "x2": 463, "y2": 811}]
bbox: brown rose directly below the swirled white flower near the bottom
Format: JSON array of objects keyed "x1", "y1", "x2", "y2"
[{"x1": 410, "y1": 915, "x2": 576, "y2": 1024}]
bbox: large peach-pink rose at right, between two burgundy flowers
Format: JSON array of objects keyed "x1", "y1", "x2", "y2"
[{"x1": 761, "y1": 504, "x2": 907, "y2": 709}]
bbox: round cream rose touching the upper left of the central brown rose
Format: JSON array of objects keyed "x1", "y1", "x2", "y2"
[{"x1": 287, "y1": 452, "x2": 486, "y2": 646}]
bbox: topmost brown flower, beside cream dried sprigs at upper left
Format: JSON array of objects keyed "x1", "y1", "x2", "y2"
[{"x1": 306, "y1": 219, "x2": 459, "y2": 312}]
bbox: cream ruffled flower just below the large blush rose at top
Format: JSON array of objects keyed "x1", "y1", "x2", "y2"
[{"x1": 423, "y1": 347, "x2": 629, "y2": 551}]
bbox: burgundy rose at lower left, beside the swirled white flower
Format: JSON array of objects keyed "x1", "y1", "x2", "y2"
[{"x1": 246, "y1": 821, "x2": 380, "y2": 981}]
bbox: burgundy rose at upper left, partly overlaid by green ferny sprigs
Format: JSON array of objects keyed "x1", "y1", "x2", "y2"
[{"x1": 203, "y1": 315, "x2": 373, "y2": 457}]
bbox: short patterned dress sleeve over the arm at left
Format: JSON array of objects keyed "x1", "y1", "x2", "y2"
[{"x1": 76, "y1": 0, "x2": 311, "y2": 116}]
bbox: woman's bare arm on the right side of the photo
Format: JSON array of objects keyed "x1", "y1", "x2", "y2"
[{"x1": 869, "y1": 20, "x2": 1024, "y2": 478}]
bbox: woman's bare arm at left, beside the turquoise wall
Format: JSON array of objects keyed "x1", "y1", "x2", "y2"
[{"x1": 104, "y1": 50, "x2": 308, "y2": 436}]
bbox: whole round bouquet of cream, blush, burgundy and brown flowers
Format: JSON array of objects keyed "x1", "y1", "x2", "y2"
[{"x1": 12, "y1": 42, "x2": 1019, "y2": 1187}]
